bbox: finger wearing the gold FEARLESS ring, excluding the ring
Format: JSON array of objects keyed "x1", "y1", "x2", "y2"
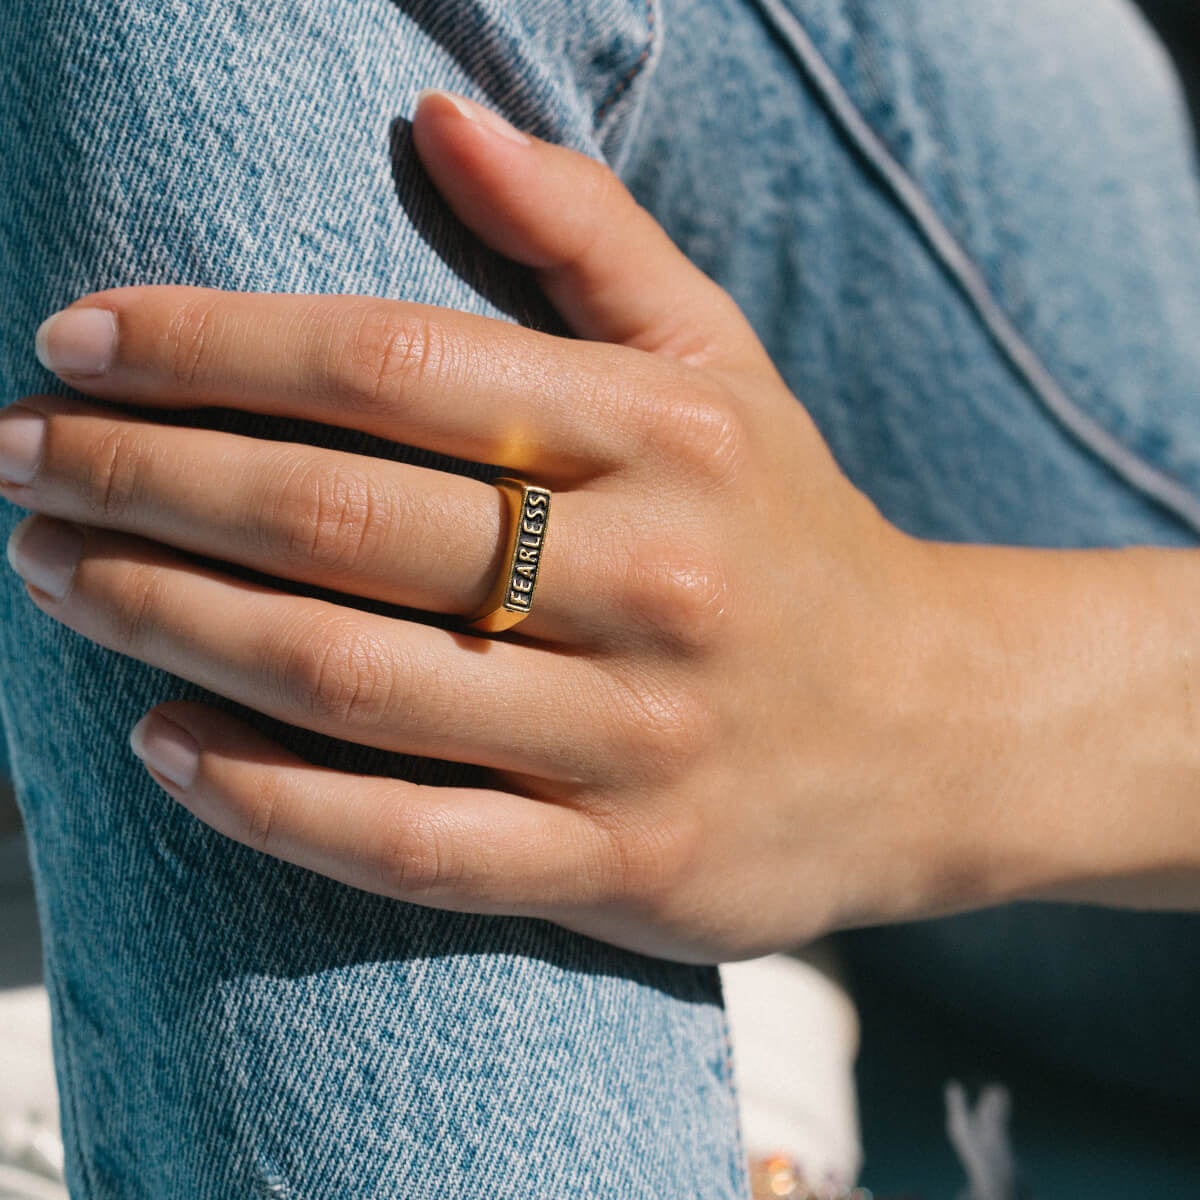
[{"x1": 0, "y1": 396, "x2": 618, "y2": 646}]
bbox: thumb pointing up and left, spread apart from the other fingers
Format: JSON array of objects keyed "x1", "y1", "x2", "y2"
[{"x1": 413, "y1": 91, "x2": 766, "y2": 367}]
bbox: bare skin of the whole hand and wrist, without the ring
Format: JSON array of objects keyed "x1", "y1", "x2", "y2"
[{"x1": 0, "y1": 94, "x2": 1200, "y2": 961}]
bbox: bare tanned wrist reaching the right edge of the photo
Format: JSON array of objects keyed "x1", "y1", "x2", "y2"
[{"x1": 907, "y1": 544, "x2": 1200, "y2": 911}]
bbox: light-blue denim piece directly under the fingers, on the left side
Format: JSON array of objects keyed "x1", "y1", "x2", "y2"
[{"x1": 0, "y1": 0, "x2": 745, "y2": 1200}]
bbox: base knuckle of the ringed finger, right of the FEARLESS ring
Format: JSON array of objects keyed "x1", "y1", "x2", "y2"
[{"x1": 623, "y1": 544, "x2": 733, "y2": 655}]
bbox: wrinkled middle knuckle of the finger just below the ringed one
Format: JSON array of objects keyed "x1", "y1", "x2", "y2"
[{"x1": 280, "y1": 617, "x2": 408, "y2": 730}]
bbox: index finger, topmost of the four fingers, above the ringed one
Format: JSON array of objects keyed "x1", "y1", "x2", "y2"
[{"x1": 37, "y1": 286, "x2": 680, "y2": 486}]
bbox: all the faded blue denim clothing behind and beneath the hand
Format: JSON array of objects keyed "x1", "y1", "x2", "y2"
[{"x1": 0, "y1": 0, "x2": 1200, "y2": 1200}]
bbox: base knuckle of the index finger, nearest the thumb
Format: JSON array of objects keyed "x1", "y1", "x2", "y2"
[{"x1": 647, "y1": 377, "x2": 746, "y2": 486}]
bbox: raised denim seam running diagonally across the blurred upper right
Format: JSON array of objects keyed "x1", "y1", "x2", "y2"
[{"x1": 739, "y1": 0, "x2": 1200, "y2": 534}]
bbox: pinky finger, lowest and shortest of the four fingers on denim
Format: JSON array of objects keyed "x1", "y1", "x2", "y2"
[{"x1": 130, "y1": 701, "x2": 608, "y2": 919}]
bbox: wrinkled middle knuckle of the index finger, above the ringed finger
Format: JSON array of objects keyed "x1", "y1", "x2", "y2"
[{"x1": 332, "y1": 305, "x2": 448, "y2": 412}]
